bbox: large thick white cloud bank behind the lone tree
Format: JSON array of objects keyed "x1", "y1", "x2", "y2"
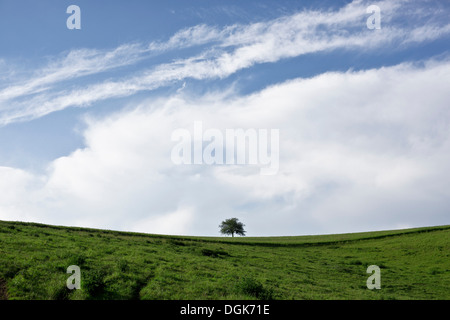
[{"x1": 0, "y1": 61, "x2": 450, "y2": 236}]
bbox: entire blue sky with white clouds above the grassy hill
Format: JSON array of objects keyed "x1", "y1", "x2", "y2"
[{"x1": 0, "y1": 0, "x2": 450, "y2": 236}]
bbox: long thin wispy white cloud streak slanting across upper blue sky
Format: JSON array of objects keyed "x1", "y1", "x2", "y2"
[{"x1": 0, "y1": 1, "x2": 450, "y2": 125}]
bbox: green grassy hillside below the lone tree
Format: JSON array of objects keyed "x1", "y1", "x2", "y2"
[{"x1": 0, "y1": 221, "x2": 450, "y2": 300}]
